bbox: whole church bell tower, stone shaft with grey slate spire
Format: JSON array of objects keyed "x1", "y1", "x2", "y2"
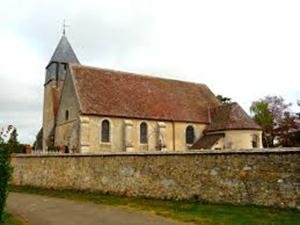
[{"x1": 43, "y1": 33, "x2": 80, "y2": 152}]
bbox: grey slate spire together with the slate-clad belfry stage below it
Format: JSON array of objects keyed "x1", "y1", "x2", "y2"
[{"x1": 45, "y1": 33, "x2": 80, "y2": 85}]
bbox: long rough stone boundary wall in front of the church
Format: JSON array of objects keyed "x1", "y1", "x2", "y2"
[{"x1": 12, "y1": 148, "x2": 300, "y2": 209}]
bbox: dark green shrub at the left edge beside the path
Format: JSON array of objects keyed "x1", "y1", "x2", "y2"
[{"x1": 0, "y1": 144, "x2": 12, "y2": 221}]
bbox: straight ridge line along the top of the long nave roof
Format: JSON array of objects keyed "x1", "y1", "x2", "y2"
[{"x1": 70, "y1": 63, "x2": 208, "y2": 88}]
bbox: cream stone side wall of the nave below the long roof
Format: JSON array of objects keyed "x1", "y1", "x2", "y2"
[{"x1": 80, "y1": 116, "x2": 205, "y2": 152}]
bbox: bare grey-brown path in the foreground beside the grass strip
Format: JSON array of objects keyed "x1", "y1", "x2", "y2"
[{"x1": 7, "y1": 193, "x2": 182, "y2": 225}]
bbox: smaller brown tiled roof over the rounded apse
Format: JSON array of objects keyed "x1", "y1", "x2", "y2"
[{"x1": 205, "y1": 103, "x2": 261, "y2": 132}]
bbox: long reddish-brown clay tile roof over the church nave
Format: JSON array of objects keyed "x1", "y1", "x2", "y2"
[{"x1": 70, "y1": 64, "x2": 220, "y2": 123}]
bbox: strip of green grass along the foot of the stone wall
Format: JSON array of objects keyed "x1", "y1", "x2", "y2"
[{"x1": 11, "y1": 187, "x2": 300, "y2": 225}]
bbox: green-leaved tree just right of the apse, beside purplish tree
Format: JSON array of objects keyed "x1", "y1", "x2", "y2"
[{"x1": 250, "y1": 100, "x2": 275, "y2": 147}]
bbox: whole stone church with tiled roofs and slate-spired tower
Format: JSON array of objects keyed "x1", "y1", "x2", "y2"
[{"x1": 41, "y1": 35, "x2": 262, "y2": 153}]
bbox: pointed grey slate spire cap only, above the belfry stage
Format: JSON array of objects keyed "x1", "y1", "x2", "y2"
[{"x1": 48, "y1": 35, "x2": 79, "y2": 65}]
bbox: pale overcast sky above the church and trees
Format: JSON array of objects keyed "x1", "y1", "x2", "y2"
[{"x1": 0, "y1": 0, "x2": 300, "y2": 143}]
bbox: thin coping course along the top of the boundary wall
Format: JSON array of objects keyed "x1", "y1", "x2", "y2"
[{"x1": 12, "y1": 147, "x2": 300, "y2": 158}]
